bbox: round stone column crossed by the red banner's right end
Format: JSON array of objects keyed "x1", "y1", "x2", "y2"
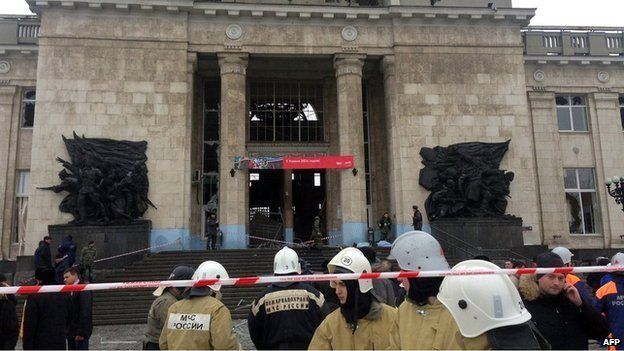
[{"x1": 334, "y1": 54, "x2": 367, "y2": 245}]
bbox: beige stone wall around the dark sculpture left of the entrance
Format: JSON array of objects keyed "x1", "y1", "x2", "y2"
[{"x1": 28, "y1": 10, "x2": 190, "y2": 250}]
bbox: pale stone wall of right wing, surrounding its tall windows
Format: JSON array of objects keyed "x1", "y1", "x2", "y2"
[{"x1": 525, "y1": 64, "x2": 624, "y2": 249}]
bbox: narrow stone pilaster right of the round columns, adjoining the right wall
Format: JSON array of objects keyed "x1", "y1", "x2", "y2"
[{"x1": 381, "y1": 55, "x2": 410, "y2": 237}]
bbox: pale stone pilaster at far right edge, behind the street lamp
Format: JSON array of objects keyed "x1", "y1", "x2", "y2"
[{"x1": 592, "y1": 93, "x2": 624, "y2": 247}]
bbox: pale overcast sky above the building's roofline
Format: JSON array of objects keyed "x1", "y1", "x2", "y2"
[{"x1": 0, "y1": 0, "x2": 624, "y2": 27}]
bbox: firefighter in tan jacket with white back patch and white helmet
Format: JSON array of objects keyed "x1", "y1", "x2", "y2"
[{"x1": 159, "y1": 261, "x2": 240, "y2": 350}]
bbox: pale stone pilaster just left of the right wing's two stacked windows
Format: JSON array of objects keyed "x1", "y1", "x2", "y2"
[{"x1": 529, "y1": 91, "x2": 570, "y2": 245}]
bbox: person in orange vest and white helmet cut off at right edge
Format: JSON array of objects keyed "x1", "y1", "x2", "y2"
[{"x1": 596, "y1": 252, "x2": 624, "y2": 350}]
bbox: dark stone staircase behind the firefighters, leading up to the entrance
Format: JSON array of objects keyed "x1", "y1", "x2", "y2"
[{"x1": 93, "y1": 248, "x2": 338, "y2": 325}]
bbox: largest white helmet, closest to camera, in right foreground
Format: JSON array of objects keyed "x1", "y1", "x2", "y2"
[{"x1": 438, "y1": 260, "x2": 531, "y2": 338}]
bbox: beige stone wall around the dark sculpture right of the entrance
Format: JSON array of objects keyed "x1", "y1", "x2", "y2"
[{"x1": 389, "y1": 26, "x2": 541, "y2": 244}]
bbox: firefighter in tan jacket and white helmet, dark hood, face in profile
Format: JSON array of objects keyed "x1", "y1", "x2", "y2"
[{"x1": 309, "y1": 247, "x2": 399, "y2": 350}]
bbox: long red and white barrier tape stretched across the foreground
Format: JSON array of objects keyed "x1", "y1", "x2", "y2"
[{"x1": 0, "y1": 266, "x2": 624, "y2": 294}]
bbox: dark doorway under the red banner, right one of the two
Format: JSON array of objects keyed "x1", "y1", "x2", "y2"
[{"x1": 292, "y1": 170, "x2": 326, "y2": 241}]
